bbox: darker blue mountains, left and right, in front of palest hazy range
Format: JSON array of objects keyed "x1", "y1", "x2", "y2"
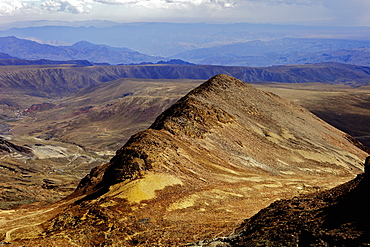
[{"x1": 0, "y1": 36, "x2": 370, "y2": 67}]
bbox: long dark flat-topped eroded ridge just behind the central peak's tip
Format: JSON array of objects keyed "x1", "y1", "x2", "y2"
[{"x1": 0, "y1": 63, "x2": 370, "y2": 96}]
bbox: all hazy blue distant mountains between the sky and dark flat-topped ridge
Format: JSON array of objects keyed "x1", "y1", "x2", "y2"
[{"x1": 0, "y1": 21, "x2": 370, "y2": 67}]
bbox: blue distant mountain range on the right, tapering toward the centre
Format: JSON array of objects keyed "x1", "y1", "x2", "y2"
[{"x1": 173, "y1": 38, "x2": 370, "y2": 66}]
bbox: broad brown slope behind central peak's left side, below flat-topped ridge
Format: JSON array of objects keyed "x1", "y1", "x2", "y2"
[{"x1": 7, "y1": 79, "x2": 201, "y2": 151}]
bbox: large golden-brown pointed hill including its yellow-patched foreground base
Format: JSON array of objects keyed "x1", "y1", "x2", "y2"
[{"x1": 7, "y1": 75, "x2": 367, "y2": 246}]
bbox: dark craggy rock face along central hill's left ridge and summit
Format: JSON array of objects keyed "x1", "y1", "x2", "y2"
[{"x1": 77, "y1": 74, "x2": 254, "y2": 193}]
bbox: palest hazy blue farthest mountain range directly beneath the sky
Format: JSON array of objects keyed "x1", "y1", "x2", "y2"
[{"x1": 0, "y1": 21, "x2": 370, "y2": 57}]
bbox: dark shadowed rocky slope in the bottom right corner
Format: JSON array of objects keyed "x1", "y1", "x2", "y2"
[{"x1": 196, "y1": 157, "x2": 370, "y2": 247}]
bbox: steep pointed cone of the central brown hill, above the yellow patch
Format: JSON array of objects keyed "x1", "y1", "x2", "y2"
[{"x1": 76, "y1": 74, "x2": 364, "y2": 199}]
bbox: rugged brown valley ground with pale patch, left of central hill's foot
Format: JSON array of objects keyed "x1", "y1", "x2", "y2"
[{"x1": 0, "y1": 137, "x2": 108, "y2": 210}]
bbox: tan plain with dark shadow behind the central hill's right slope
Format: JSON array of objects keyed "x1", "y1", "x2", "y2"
[{"x1": 255, "y1": 83, "x2": 370, "y2": 147}]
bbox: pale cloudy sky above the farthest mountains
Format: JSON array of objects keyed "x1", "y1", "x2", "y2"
[{"x1": 0, "y1": 0, "x2": 370, "y2": 26}]
